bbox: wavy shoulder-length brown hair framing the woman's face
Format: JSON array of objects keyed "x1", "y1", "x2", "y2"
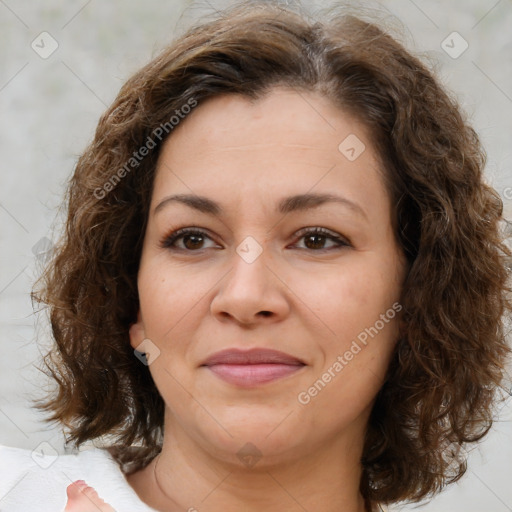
[{"x1": 32, "y1": 2, "x2": 512, "y2": 506}]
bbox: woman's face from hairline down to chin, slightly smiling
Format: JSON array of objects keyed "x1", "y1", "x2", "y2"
[{"x1": 130, "y1": 88, "x2": 405, "y2": 464}]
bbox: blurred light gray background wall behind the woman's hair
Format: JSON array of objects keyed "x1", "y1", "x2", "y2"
[{"x1": 0, "y1": 0, "x2": 512, "y2": 512}]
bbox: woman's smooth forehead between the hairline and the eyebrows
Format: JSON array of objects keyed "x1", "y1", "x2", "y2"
[{"x1": 153, "y1": 88, "x2": 385, "y2": 220}]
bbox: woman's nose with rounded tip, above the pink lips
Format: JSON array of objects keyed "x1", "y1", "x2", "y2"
[{"x1": 210, "y1": 242, "x2": 290, "y2": 326}]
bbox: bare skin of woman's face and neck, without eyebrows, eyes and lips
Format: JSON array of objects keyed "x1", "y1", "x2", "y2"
[{"x1": 127, "y1": 88, "x2": 405, "y2": 512}]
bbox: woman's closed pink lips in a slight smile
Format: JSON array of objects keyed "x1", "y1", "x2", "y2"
[{"x1": 201, "y1": 348, "x2": 306, "y2": 387}]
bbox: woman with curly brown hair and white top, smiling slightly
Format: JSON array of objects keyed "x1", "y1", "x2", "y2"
[{"x1": 3, "y1": 3, "x2": 512, "y2": 512}]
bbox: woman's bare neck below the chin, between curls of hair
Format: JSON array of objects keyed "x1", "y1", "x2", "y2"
[{"x1": 128, "y1": 410, "x2": 368, "y2": 512}]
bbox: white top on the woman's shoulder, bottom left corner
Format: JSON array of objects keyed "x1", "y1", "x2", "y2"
[{"x1": 0, "y1": 443, "x2": 155, "y2": 512}]
